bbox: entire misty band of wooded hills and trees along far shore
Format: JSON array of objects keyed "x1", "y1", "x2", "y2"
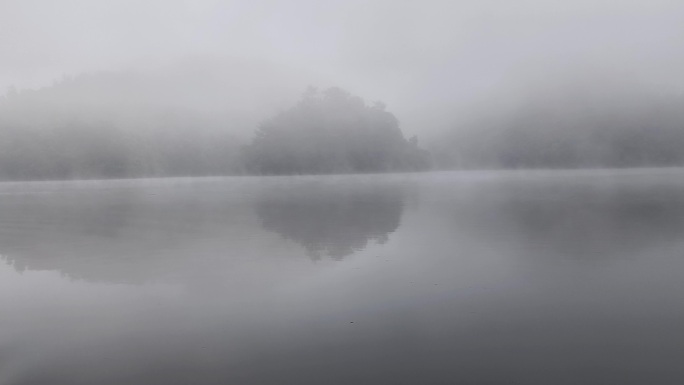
[{"x1": 0, "y1": 69, "x2": 684, "y2": 180}]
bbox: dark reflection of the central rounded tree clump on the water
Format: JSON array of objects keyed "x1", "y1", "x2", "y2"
[{"x1": 256, "y1": 182, "x2": 404, "y2": 260}]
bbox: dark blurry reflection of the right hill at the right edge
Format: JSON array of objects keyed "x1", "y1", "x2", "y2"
[{"x1": 501, "y1": 190, "x2": 684, "y2": 261}]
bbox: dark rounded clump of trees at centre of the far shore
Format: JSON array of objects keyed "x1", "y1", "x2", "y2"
[{"x1": 244, "y1": 87, "x2": 428, "y2": 174}]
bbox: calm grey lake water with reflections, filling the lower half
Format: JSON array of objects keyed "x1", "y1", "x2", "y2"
[{"x1": 0, "y1": 169, "x2": 684, "y2": 385}]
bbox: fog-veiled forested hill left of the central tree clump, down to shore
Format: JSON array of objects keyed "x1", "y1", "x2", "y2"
[{"x1": 0, "y1": 59, "x2": 311, "y2": 180}]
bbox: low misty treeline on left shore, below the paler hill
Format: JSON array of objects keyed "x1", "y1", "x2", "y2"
[{"x1": 0, "y1": 111, "x2": 241, "y2": 180}]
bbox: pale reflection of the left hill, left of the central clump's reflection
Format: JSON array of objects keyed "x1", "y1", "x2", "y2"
[{"x1": 0, "y1": 181, "x2": 259, "y2": 284}]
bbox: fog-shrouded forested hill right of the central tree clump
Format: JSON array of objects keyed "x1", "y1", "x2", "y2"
[{"x1": 432, "y1": 83, "x2": 684, "y2": 169}]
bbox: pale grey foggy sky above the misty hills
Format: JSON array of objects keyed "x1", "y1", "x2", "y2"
[{"x1": 0, "y1": 0, "x2": 684, "y2": 136}]
